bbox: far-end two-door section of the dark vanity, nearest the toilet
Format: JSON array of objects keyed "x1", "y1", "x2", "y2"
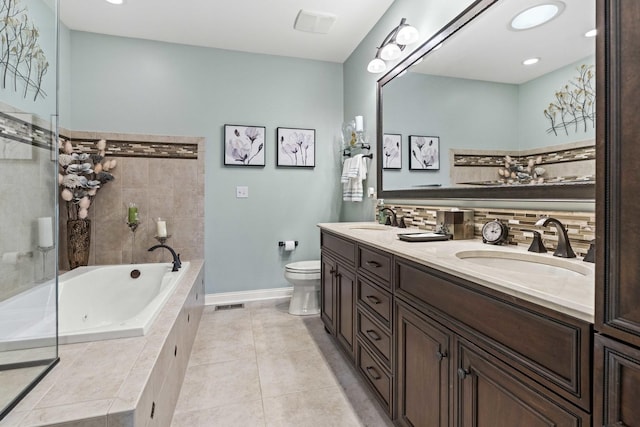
[{"x1": 320, "y1": 233, "x2": 356, "y2": 359}]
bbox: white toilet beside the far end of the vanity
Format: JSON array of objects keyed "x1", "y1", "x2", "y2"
[{"x1": 284, "y1": 261, "x2": 320, "y2": 316}]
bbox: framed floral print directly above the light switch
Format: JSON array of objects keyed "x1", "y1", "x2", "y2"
[{"x1": 224, "y1": 125, "x2": 266, "y2": 166}]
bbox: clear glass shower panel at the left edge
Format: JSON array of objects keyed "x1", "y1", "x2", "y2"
[{"x1": 0, "y1": 0, "x2": 58, "y2": 419}]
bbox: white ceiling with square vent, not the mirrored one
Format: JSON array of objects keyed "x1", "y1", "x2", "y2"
[{"x1": 60, "y1": 0, "x2": 393, "y2": 63}]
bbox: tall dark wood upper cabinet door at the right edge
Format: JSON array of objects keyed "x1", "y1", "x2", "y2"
[{"x1": 596, "y1": 0, "x2": 640, "y2": 346}]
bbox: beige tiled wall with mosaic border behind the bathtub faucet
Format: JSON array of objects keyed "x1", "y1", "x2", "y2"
[{"x1": 59, "y1": 129, "x2": 205, "y2": 270}]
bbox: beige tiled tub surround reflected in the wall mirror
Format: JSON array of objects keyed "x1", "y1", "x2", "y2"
[{"x1": 449, "y1": 140, "x2": 596, "y2": 185}]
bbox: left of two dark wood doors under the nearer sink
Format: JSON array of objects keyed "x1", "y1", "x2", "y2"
[{"x1": 396, "y1": 304, "x2": 450, "y2": 427}]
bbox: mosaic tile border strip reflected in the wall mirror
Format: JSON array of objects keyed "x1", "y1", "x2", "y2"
[{"x1": 453, "y1": 145, "x2": 596, "y2": 167}]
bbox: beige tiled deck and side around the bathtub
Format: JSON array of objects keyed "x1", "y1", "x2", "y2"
[{"x1": 0, "y1": 260, "x2": 204, "y2": 427}]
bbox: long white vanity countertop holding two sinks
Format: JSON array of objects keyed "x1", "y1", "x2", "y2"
[{"x1": 318, "y1": 222, "x2": 595, "y2": 323}]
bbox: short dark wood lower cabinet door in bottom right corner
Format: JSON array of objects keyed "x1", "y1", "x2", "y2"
[{"x1": 594, "y1": 334, "x2": 640, "y2": 427}]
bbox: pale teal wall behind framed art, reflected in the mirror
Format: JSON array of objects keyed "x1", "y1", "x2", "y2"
[{"x1": 383, "y1": 73, "x2": 518, "y2": 190}]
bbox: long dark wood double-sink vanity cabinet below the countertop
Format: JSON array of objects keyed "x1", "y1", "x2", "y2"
[{"x1": 322, "y1": 232, "x2": 592, "y2": 427}]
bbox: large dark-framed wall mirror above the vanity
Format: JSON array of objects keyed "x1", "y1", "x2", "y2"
[{"x1": 377, "y1": 0, "x2": 596, "y2": 200}]
